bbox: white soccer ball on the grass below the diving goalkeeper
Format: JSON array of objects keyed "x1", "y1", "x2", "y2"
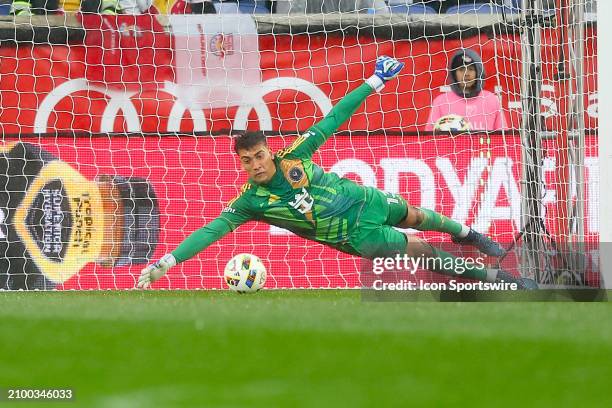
[{"x1": 224, "y1": 254, "x2": 267, "y2": 293}]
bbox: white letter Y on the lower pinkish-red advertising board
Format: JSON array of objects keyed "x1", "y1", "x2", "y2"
[{"x1": 436, "y1": 157, "x2": 488, "y2": 224}]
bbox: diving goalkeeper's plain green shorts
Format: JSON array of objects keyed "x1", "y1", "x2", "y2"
[{"x1": 344, "y1": 187, "x2": 408, "y2": 259}]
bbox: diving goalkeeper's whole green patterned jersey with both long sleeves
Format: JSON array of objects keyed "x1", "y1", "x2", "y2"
[{"x1": 172, "y1": 84, "x2": 384, "y2": 262}]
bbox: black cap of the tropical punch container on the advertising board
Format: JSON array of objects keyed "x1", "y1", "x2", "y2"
[{"x1": 110, "y1": 176, "x2": 159, "y2": 266}]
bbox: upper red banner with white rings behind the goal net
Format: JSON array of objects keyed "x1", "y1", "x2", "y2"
[{"x1": 0, "y1": 27, "x2": 597, "y2": 134}]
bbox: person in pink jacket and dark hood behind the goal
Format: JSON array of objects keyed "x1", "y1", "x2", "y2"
[{"x1": 426, "y1": 49, "x2": 508, "y2": 131}]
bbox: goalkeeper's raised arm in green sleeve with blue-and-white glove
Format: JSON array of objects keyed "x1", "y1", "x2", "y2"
[{"x1": 278, "y1": 56, "x2": 404, "y2": 158}]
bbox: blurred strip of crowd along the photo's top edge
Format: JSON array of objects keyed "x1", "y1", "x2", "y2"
[{"x1": 0, "y1": 0, "x2": 597, "y2": 16}]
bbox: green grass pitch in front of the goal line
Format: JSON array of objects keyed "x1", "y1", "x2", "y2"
[{"x1": 0, "y1": 290, "x2": 612, "y2": 408}]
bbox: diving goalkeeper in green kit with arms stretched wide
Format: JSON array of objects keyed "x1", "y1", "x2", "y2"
[{"x1": 138, "y1": 56, "x2": 526, "y2": 288}]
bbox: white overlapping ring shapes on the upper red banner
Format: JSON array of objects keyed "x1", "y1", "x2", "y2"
[{"x1": 34, "y1": 77, "x2": 333, "y2": 133}]
